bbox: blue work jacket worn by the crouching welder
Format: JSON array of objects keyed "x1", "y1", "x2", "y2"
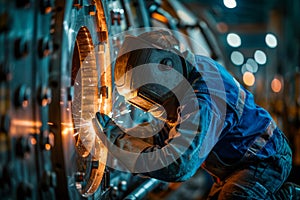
[{"x1": 139, "y1": 56, "x2": 278, "y2": 181}]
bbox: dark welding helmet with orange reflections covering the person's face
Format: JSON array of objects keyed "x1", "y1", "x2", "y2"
[{"x1": 114, "y1": 31, "x2": 187, "y2": 111}]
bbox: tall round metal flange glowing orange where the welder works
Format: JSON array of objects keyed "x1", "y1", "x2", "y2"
[{"x1": 49, "y1": 1, "x2": 111, "y2": 199}]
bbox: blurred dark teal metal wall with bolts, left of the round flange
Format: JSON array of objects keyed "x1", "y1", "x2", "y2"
[{"x1": 0, "y1": 1, "x2": 55, "y2": 199}]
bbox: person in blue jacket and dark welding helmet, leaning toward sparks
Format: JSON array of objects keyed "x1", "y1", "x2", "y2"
[{"x1": 94, "y1": 30, "x2": 300, "y2": 199}]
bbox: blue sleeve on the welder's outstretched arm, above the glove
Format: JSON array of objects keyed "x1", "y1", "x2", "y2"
[{"x1": 136, "y1": 94, "x2": 214, "y2": 182}]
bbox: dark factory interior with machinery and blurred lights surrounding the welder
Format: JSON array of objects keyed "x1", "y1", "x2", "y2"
[{"x1": 0, "y1": 0, "x2": 300, "y2": 200}]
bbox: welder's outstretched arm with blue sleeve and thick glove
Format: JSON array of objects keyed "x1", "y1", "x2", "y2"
[{"x1": 96, "y1": 91, "x2": 214, "y2": 181}]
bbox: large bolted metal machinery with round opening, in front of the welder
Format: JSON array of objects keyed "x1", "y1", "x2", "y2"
[{"x1": 0, "y1": 0, "x2": 218, "y2": 199}]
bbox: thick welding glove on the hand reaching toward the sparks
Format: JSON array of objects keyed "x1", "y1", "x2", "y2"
[{"x1": 93, "y1": 112, "x2": 152, "y2": 172}]
